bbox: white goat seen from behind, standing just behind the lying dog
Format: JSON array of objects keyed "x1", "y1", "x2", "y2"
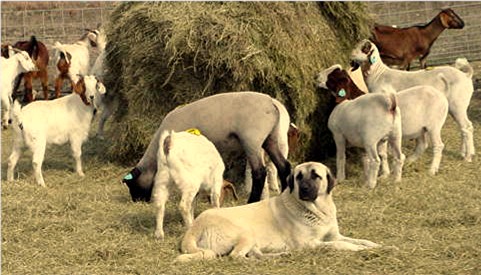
[{"x1": 152, "y1": 129, "x2": 225, "y2": 239}]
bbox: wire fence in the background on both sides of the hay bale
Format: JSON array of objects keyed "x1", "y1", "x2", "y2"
[{"x1": 1, "y1": 1, "x2": 481, "y2": 87}]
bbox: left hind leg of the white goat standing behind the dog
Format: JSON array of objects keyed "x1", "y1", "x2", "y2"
[{"x1": 152, "y1": 169, "x2": 170, "y2": 240}]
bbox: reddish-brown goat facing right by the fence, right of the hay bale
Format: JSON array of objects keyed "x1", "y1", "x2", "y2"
[{"x1": 370, "y1": 9, "x2": 464, "y2": 70}]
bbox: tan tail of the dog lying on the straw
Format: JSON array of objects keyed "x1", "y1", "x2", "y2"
[{"x1": 175, "y1": 231, "x2": 217, "y2": 262}]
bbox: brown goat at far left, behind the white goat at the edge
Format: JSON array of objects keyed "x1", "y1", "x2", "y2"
[{"x1": 2, "y1": 36, "x2": 49, "y2": 103}]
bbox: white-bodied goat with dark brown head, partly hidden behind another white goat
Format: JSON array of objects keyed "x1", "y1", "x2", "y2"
[{"x1": 319, "y1": 65, "x2": 448, "y2": 175}]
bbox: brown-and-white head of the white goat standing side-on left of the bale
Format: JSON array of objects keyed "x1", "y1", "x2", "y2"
[{"x1": 74, "y1": 75, "x2": 106, "y2": 108}]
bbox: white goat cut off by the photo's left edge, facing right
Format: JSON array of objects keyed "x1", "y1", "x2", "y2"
[{"x1": 0, "y1": 46, "x2": 37, "y2": 129}]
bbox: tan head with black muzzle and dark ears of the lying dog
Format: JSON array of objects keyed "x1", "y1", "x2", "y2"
[{"x1": 287, "y1": 162, "x2": 336, "y2": 202}]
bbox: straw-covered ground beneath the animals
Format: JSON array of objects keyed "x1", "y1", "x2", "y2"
[{"x1": 1, "y1": 4, "x2": 481, "y2": 274}]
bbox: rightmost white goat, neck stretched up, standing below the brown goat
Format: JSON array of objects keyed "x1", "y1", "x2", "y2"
[{"x1": 351, "y1": 39, "x2": 475, "y2": 162}]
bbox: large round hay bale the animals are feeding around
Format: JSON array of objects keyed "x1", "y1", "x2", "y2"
[{"x1": 105, "y1": 2, "x2": 370, "y2": 166}]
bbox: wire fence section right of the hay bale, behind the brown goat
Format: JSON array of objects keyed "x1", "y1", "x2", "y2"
[{"x1": 368, "y1": 1, "x2": 481, "y2": 67}]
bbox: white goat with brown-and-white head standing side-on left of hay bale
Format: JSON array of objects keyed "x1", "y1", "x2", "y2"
[{"x1": 7, "y1": 76, "x2": 105, "y2": 186}]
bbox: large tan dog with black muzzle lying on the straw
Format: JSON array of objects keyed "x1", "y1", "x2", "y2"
[{"x1": 176, "y1": 162, "x2": 379, "y2": 262}]
